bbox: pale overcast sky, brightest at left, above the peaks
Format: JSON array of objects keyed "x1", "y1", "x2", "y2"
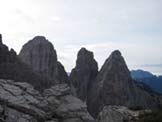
[{"x1": 0, "y1": 0, "x2": 162, "y2": 74}]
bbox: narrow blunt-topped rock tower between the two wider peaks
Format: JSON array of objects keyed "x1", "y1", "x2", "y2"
[{"x1": 70, "y1": 48, "x2": 98, "y2": 101}]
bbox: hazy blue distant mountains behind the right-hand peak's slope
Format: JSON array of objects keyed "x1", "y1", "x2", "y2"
[{"x1": 131, "y1": 70, "x2": 162, "y2": 93}]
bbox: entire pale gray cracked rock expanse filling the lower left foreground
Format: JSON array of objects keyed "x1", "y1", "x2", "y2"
[{"x1": 0, "y1": 79, "x2": 94, "y2": 122}]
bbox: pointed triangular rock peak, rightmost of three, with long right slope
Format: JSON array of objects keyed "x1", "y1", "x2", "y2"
[{"x1": 87, "y1": 50, "x2": 159, "y2": 117}]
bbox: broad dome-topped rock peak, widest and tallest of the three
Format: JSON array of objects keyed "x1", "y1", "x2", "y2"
[{"x1": 19, "y1": 36, "x2": 68, "y2": 84}]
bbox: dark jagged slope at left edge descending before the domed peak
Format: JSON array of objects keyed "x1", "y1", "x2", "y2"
[{"x1": 0, "y1": 33, "x2": 53, "y2": 91}]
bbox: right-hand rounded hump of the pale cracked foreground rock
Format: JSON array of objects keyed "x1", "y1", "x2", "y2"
[{"x1": 44, "y1": 84, "x2": 94, "y2": 122}]
